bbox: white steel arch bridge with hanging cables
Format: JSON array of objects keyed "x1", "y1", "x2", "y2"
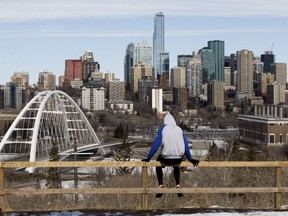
[{"x1": 0, "y1": 91, "x2": 101, "y2": 165}]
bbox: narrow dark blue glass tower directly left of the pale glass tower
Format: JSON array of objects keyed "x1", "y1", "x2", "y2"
[{"x1": 124, "y1": 43, "x2": 134, "y2": 87}]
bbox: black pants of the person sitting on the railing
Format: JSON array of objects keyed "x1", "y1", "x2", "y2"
[{"x1": 156, "y1": 154, "x2": 182, "y2": 185}]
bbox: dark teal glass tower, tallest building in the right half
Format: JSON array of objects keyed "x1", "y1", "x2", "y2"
[{"x1": 208, "y1": 40, "x2": 224, "y2": 82}]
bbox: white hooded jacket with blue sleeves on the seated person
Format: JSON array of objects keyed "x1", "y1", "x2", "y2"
[{"x1": 147, "y1": 114, "x2": 192, "y2": 161}]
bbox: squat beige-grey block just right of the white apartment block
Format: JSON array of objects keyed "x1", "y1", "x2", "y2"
[{"x1": 107, "y1": 80, "x2": 125, "y2": 100}]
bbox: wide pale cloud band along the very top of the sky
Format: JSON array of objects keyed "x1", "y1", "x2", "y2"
[{"x1": 0, "y1": 0, "x2": 288, "y2": 22}]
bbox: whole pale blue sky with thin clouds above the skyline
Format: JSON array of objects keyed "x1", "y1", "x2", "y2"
[{"x1": 0, "y1": 0, "x2": 288, "y2": 85}]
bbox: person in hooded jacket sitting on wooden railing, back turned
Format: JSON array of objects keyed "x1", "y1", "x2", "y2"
[{"x1": 142, "y1": 113, "x2": 199, "y2": 198}]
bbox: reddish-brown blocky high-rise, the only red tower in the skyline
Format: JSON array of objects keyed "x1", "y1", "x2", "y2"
[{"x1": 64, "y1": 59, "x2": 82, "y2": 81}]
